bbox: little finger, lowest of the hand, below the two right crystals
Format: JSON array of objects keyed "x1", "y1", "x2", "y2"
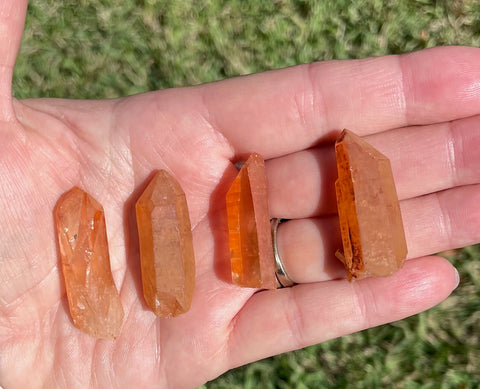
[{"x1": 229, "y1": 257, "x2": 458, "y2": 366}]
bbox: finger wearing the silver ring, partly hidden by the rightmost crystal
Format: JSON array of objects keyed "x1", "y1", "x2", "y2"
[{"x1": 277, "y1": 185, "x2": 480, "y2": 283}]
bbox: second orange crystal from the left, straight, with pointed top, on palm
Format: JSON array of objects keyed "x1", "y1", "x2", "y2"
[{"x1": 136, "y1": 170, "x2": 195, "y2": 317}]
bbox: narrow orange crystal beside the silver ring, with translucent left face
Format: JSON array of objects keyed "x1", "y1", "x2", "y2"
[{"x1": 226, "y1": 153, "x2": 277, "y2": 289}]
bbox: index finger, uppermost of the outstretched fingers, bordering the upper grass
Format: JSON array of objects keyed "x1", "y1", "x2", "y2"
[{"x1": 197, "y1": 47, "x2": 480, "y2": 158}]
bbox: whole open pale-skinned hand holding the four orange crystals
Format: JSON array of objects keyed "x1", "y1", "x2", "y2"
[{"x1": 0, "y1": 0, "x2": 480, "y2": 388}]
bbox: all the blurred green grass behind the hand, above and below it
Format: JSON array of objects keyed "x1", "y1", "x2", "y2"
[{"x1": 13, "y1": 0, "x2": 480, "y2": 389}]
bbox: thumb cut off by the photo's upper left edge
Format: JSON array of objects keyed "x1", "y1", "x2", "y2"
[{"x1": 0, "y1": 0, "x2": 27, "y2": 121}]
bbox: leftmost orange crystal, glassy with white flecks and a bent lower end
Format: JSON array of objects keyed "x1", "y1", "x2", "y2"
[{"x1": 54, "y1": 187, "x2": 123, "y2": 339}]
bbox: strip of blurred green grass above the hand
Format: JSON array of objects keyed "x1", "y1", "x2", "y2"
[{"x1": 14, "y1": 0, "x2": 480, "y2": 98}]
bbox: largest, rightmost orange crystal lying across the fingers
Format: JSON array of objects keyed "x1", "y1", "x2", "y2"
[{"x1": 335, "y1": 130, "x2": 407, "y2": 280}]
